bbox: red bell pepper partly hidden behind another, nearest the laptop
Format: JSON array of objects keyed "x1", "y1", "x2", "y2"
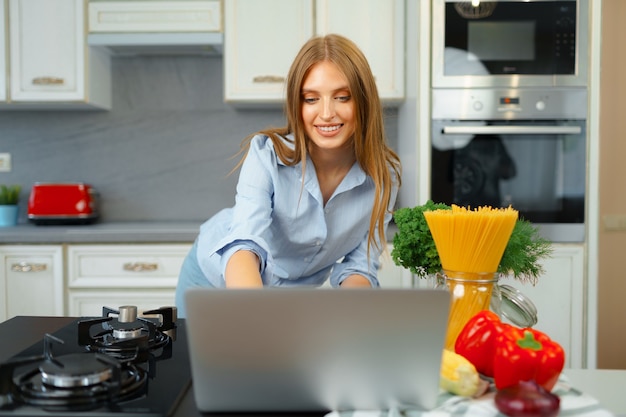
[{"x1": 454, "y1": 310, "x2": 509, "y2": 377}]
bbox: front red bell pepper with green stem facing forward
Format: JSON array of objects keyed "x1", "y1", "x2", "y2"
[{"x1": 493, "y1": 326, "x2": 565, "y2": 391}]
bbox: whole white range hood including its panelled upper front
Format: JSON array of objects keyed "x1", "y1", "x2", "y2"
[{"x1": 87, "y1": 0, "x2": 224, "y2": 55}]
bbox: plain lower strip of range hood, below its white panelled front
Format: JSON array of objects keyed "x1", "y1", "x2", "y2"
[{"x1": 87, "y1": 32, "x2": 224, "y2": 56}]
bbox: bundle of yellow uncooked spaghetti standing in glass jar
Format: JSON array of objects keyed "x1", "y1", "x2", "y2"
[{"x1": 424, "y1": 205, "x2": 518, "y2": 350}]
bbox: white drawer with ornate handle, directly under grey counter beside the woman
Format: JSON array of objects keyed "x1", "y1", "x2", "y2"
[{"x1": 67, "y1": 244, "x2": 191, "y2": 289}]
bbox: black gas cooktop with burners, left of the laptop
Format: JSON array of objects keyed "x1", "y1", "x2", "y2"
[{"x1": 0, "y1": 306, "x2": 191, "y2": 417}]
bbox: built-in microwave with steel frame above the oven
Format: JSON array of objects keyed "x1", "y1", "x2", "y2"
[{"x1": 432, "y1": 0, "x2": 589, "y2": 88}]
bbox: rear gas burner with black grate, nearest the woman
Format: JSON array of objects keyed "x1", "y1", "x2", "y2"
[{"x1": 78, "y1": 306, "x2": 176, "y2": 361}]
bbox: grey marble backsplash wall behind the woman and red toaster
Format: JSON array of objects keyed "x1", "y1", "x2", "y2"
[{"x1": 0, "y1": 56, "x2": 397, "y2": 223}]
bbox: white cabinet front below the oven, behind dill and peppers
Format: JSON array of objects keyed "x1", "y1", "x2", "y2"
[{"x1": 501, "y1": 244, "x2": 586, "y2": 368}]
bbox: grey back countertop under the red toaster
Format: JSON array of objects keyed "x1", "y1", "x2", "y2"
[{"x1": 0, "y1": 222, "x2": 202, "y2": 244}]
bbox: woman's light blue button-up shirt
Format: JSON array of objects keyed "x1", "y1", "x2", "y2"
[{"x1": 183, "y1": 135, "x2": 397, "y2": 287}]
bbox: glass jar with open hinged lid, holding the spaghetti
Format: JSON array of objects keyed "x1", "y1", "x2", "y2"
[{"x1": 435, "y1": 270, "x2": 537, "y2": 350}]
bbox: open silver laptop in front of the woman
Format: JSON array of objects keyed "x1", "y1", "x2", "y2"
[{"x1": 185, "y1": 288, "x2": 450, "y2": 412}]
